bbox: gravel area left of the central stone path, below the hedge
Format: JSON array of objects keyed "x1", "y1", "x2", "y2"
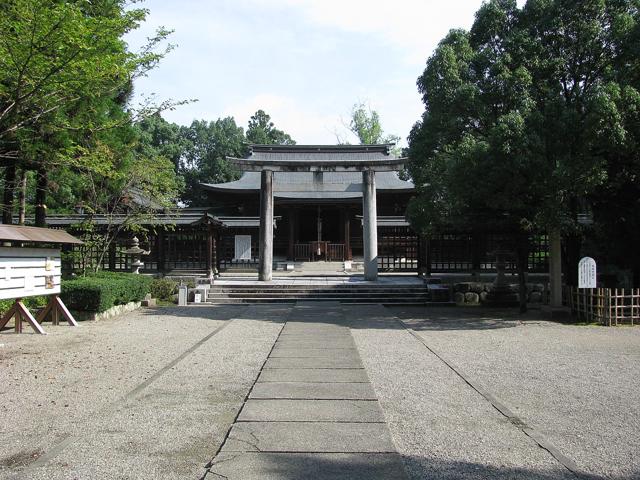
[{"x1": 0, "y1": 307, "x2": 286, "y2": 479}]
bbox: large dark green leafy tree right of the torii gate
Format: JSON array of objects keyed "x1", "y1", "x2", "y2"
[{"x1": 410, "y1": 0, "x2": 637, "y2": 304}]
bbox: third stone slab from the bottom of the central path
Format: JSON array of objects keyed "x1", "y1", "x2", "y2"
[{"x1": 238, "y1": 399, "x2": 385, "y2": 423}]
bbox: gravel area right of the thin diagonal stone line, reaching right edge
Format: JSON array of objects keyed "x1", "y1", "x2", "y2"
[{"x1": 388, "y1": 308, "x2": 640, "y2": 479}]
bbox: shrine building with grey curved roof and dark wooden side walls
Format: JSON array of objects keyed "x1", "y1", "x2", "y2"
[{"x1": 47, "y1": 145, "x2": 548, "y2": 281}]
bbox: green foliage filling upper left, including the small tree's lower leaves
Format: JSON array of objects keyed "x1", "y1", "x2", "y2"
[{"x1": 0, "y1": 0, "x2": 182, "y2": 223}]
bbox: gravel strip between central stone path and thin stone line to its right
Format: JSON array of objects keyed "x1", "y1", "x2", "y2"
[{"x1": 347, "y1": 306, "x2": 575, "y2": 480}]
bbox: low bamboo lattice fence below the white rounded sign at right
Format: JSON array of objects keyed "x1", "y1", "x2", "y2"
[{"x1": 566, "y1": 287, "x2": 640, "y2": 326}]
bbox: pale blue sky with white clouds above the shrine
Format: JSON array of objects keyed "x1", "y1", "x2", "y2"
[{"x1": 127, "y1": 0, "x2": 524, "y2": 146}]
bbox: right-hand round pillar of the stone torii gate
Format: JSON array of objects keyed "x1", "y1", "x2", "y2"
[{"x1": 362, "y1": 170, "x2": 378, "y2": 281}]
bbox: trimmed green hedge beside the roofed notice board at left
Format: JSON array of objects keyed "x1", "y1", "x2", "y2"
[{"x1": 60, "y1": 272, "x2": 153, "y2": 313}]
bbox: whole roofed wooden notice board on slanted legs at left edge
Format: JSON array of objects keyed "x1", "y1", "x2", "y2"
[{"x1": 0, "y1": 225, "x2": 82, "y2": 334}]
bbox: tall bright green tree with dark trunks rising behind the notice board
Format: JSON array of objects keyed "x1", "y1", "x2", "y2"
[{"x1": 0, "y1": 0, "x2": 175, "y2": 223}]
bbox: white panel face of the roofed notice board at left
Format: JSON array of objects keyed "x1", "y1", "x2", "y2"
[{"x1": 0, "y1": 247, "x2": 62, "y2": 300}]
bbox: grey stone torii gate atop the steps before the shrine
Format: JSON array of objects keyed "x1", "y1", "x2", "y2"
[{"x1": 229, "y1": 154, "x2": 406, "y2": 282}]
